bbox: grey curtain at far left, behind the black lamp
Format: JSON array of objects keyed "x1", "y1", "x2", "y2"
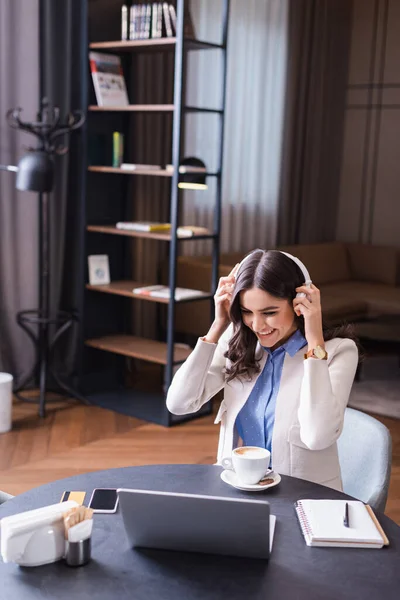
[{"x1": 0, "y1": 0, "x2": 39, "y2": 385}]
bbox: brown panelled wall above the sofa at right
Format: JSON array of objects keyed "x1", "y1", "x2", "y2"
[{"x1": 337, "y1": 0, "x2": 400, "y2": 245}]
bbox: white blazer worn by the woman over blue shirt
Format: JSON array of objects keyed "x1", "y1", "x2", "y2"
[{"x1": 167, "y1": 327, "x2": 358, "y2": 490}]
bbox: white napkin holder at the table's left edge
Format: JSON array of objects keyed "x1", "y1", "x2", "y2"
[{"x1": 1, "y1": 500, "x2": 78, "y2": 567}]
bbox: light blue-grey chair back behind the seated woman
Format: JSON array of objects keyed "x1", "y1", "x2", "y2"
[{"x1": 338, "y1": 408, "x2": 392, "y2": 512}]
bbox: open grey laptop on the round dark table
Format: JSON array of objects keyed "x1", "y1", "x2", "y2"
[{"x1": 118, "y1": 488, "x2": 275, "y2": 559}]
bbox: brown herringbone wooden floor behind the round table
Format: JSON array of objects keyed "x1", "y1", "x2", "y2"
[{"x1": 0, "y1": 394, "x2": 400, "y2": 524}]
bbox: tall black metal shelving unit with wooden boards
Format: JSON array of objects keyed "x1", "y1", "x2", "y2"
[{"x1": 82, "y1": 0, "x2": 229, "y2": 426}]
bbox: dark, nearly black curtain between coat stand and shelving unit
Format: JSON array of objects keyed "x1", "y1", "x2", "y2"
[{"x1": 41, "y1": 0, "x2": 88, "y2": 375}]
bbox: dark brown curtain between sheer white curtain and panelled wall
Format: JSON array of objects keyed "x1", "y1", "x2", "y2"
[{"x1": 278, "y1": 0, "x2": 352, "y2": 244}]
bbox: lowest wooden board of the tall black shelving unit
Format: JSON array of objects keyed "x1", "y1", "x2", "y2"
[{"x1": 85, "y1": 335, "x2": 191, "y2": 365}]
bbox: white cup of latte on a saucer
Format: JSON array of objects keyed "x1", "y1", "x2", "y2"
[{"x1": 221, "y1": 446, "x2": 271, "y2": 485}]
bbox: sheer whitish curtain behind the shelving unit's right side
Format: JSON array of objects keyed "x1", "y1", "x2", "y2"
[{"x1": 183, "y1": 0, "x2": 288, "y2": 254}]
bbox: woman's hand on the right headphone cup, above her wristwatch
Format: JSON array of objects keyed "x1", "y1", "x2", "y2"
[{"x1": 293, "y1": 283, "x2": 324, "y2": 350}]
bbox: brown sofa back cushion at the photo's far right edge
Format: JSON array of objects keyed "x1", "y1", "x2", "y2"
[{"x1": 347, "y1": 244, "x2": 398, "y2": 285}]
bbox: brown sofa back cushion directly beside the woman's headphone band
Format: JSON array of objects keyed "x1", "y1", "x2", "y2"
[{"x1": 279, "y1": 242, "x2": 350, "y2": 286}]
